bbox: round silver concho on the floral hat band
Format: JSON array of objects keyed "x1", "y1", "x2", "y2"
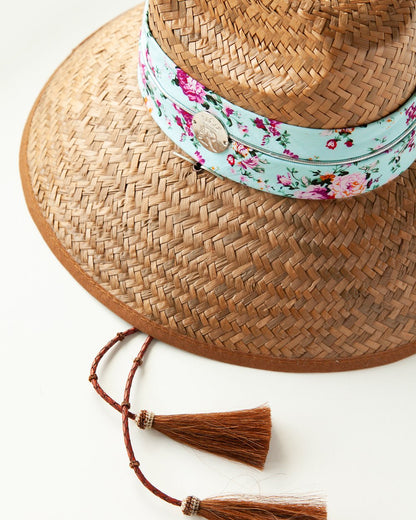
[{"x1": 192, "y1": 111, "x2": 229, "y2": 153}]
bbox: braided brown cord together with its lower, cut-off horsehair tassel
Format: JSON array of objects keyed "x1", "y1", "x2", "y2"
[{"x1": 121, "y1": 343, "x2": 327, "y2": 520}]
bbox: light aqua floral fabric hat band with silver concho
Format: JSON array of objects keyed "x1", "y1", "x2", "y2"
[{"x1": 138, "y1": 3, "x2": 416, "y2": 199}]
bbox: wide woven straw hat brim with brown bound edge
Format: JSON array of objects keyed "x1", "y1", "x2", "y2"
[{"x1": 21, "y1": 3, "x2": 416, "y2": 371}]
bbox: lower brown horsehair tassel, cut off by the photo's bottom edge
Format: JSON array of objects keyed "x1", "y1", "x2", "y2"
[{"x1": 181, "y1": 496, "x2": 327, "y2": 520}]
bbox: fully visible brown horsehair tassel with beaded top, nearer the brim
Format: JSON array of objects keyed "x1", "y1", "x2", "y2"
[{"x1": 136, "y1": 406, "x2": 272, "y2": 469}]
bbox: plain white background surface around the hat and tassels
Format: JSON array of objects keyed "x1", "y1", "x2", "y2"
[{"x1": 0, "y1": 0, "x2": 416, "y2": 520}]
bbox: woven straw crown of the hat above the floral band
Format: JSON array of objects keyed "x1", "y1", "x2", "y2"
[{"x1": 149, "y1": 0, "x2": 416, "y2": 128}]
